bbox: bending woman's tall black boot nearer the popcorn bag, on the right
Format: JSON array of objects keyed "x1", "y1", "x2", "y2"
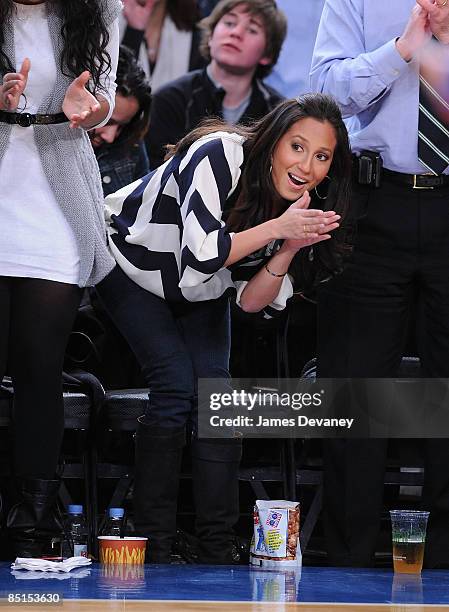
[{"x1": 192, "y1": 439, "x2": 242, "y2": 565}]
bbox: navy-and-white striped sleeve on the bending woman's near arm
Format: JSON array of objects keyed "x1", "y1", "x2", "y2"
[{"x1": 178, "y1": 134, "x2": 243, "y2": 288}]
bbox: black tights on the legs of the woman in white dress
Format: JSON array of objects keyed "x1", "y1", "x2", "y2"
[{"x1": 0, "y1": 276, "x2": 81, "y2": 479}]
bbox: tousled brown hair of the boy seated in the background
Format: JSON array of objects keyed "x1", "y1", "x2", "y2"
[{"x1": 199, "y1": 0, "x2": 288, "y2": 79}]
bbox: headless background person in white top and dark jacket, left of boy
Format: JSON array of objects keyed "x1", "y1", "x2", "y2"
[{"x1": 121, "y1": 0, "x2": 206, "y2": 90}]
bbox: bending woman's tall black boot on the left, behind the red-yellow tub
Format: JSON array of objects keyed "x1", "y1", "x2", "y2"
[{"x1": 134, "y1": 419, "x2": 185, "y2": 563}]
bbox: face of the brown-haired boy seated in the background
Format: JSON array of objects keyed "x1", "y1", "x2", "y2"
[{"x1": 209, "y1": 2, "x2": 271, "y2": 74}]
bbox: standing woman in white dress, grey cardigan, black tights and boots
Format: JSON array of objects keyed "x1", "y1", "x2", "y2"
[{"x1": 0, "y1": 0, "x2": 121, "y2": 557}]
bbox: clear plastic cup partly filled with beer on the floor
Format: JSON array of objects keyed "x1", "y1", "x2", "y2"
[{"x1": 390, "y1": 510, "x2": 429, "y2": 574}]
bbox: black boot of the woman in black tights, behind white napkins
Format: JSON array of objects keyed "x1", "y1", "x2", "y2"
[{"x1": 6, "y1": 478, "x2": 62, "y2": 558}]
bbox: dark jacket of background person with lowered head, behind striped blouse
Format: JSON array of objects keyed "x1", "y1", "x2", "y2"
[{"x1": 94, "y1": 138, "x2": 149, "y2": 197}]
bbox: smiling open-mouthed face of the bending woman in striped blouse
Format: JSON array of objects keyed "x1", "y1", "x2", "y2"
[{"x1": 271, "y1": 117, "x2": 337, "y2": 201}]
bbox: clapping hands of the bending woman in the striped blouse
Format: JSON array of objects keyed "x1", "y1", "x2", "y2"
[{"x1": 274, "y1": 191, "x2": 340, "y2": 251}]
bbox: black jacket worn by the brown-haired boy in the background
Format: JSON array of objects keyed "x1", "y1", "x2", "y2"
[{"x1": 146, "y1": 68, "x2": 283, "y2": 170}]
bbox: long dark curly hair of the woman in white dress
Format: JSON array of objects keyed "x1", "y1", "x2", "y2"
[{"x1": 0, "y1": 0, "x2": 111, "y2": 92}]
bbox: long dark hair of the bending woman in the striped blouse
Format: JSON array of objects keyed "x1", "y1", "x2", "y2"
[{"x1": 166, "y1": 94, "x2": 352, "y2": 287}]
